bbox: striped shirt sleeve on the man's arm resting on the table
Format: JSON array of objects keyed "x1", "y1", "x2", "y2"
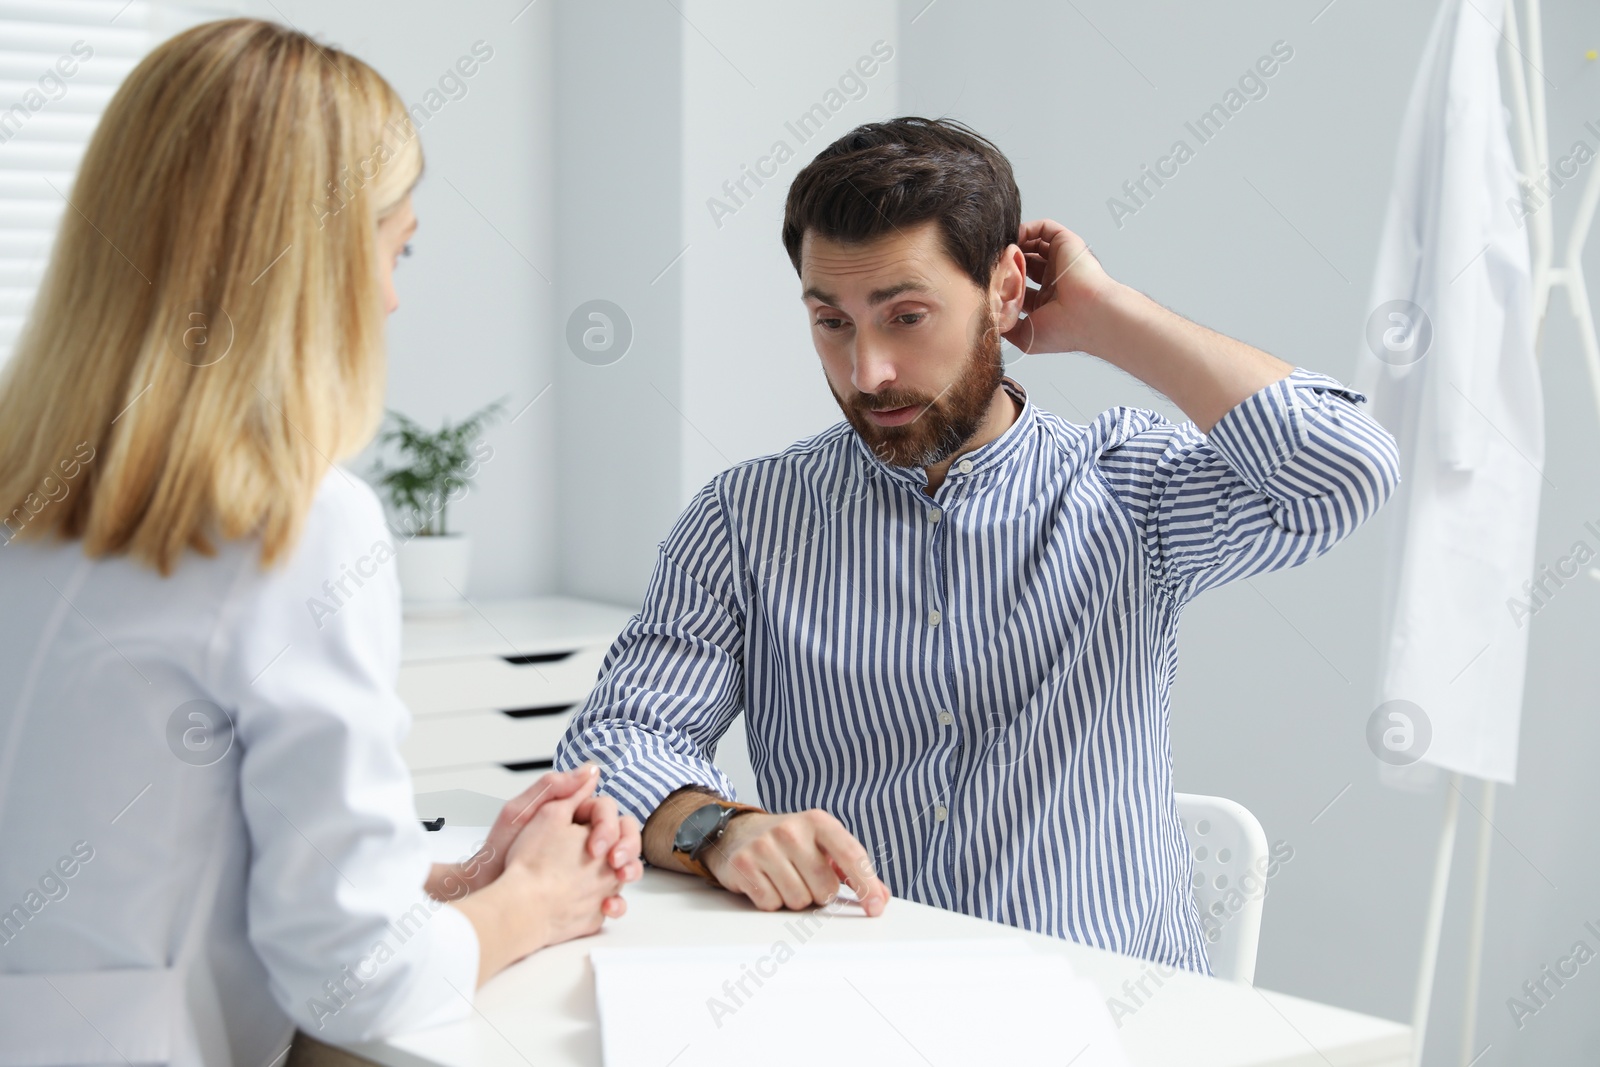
[{"x1": 555, "y1": 482, "x2": 744, "y2": 822}]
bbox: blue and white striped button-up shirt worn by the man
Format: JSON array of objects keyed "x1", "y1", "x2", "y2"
[{"x1": 557, "y1": 368, "x2": 1398, "y2": 973}]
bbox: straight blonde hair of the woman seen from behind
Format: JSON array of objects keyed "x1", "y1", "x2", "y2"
[{"x1": 0, "y1": 19, "x2": 422, "y2": 574}]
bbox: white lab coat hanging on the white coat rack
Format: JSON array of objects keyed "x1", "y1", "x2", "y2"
[{"x1": 1354, "y1": 0, "x2": 1544, "y2": 784}]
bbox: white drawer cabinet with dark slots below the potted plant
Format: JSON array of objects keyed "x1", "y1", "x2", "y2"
[{"x1": 398, "y1": 597, "x2": 632, "y2": 797}]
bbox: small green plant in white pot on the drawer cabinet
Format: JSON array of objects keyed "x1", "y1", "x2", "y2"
[{"x1": 373, "y1": 400, "x2": 504, "y2": 616}]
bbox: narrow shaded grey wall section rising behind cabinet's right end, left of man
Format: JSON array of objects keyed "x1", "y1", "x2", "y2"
[{"x1": 553, "y1": 0, "x2": 686, "y2": 603}]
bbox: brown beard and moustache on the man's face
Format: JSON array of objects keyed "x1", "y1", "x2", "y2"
[{"x1": 827, "y1": 304, "x2": 1005, "y2": 467}]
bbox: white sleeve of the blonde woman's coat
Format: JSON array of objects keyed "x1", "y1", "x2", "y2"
[{"x1": 216, "y1": 472, "x2": 478, "y2": 1043}]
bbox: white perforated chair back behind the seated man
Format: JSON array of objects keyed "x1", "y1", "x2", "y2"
[{"x1": 1178, "y1": 793, "x2": 1267, "y2": 984}]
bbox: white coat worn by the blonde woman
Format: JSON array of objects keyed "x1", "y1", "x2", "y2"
[{"x1": 0, "y1": 470, "x2": 478, "y2": 1067}]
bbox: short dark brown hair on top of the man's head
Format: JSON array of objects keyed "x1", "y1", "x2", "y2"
[{"x1": 784, "y1": 115, "x2": 1022, "y2": 288}]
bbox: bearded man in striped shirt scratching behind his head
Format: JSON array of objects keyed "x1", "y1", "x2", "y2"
[{"x1": 557, "y1": 118, "x2": 1398, "y2": 973}]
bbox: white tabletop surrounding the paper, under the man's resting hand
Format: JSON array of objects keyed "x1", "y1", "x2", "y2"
[{"x1": 352, "y1": 825, "x2": 1411, "y2": 1067}]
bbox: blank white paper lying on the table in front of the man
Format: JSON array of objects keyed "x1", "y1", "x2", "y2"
[{"x1": 589, "y1": 940, "x2": 1128, "y2": 1067}]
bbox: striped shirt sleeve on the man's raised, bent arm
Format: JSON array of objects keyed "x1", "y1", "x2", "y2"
[{"x1": 1098, "y1": 368, "x2": 1400, "y2": 600}]
